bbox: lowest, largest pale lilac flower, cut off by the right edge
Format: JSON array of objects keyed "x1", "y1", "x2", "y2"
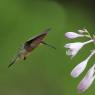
[{"x1": 77, "y1": 64, "x2": 95, "y2": 93}]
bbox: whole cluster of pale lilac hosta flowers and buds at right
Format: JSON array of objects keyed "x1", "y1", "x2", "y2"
[{"x1": 64, "y1": 29, "x2": 95, "y2": 92}]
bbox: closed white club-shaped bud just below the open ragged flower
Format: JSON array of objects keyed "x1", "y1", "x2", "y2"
[{"x1": 71, "y1": 51, "x2": 95, "y2": 78}]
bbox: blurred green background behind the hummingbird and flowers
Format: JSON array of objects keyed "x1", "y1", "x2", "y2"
[{"x1": 0, "y1": 0, "x2": 95, "y2": 95}]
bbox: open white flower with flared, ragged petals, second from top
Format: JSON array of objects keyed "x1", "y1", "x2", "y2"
[{"x1": 64, "y1": 40, "x2": 94, "y2": 57}]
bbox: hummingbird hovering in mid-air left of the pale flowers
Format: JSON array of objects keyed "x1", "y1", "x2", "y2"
[{"x1": 8, "y1": 28, "x2": 56, "y2": 68}]
